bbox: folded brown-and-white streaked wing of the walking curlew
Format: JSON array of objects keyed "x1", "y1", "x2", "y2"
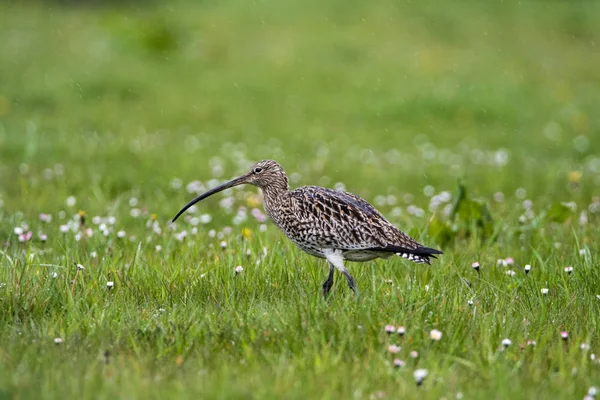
[{"x1": 291, "y1": 186, "x2": 420, "y2": 251}]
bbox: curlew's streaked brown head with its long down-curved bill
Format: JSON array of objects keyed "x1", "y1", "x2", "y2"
[{"x1": 172, "y1": 160, "x2": 288, "y2": 222}]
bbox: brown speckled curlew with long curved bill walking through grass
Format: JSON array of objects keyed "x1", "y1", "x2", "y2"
[{"x1": 172, "y1": 160, "x2": 442, "y2": 297}]
